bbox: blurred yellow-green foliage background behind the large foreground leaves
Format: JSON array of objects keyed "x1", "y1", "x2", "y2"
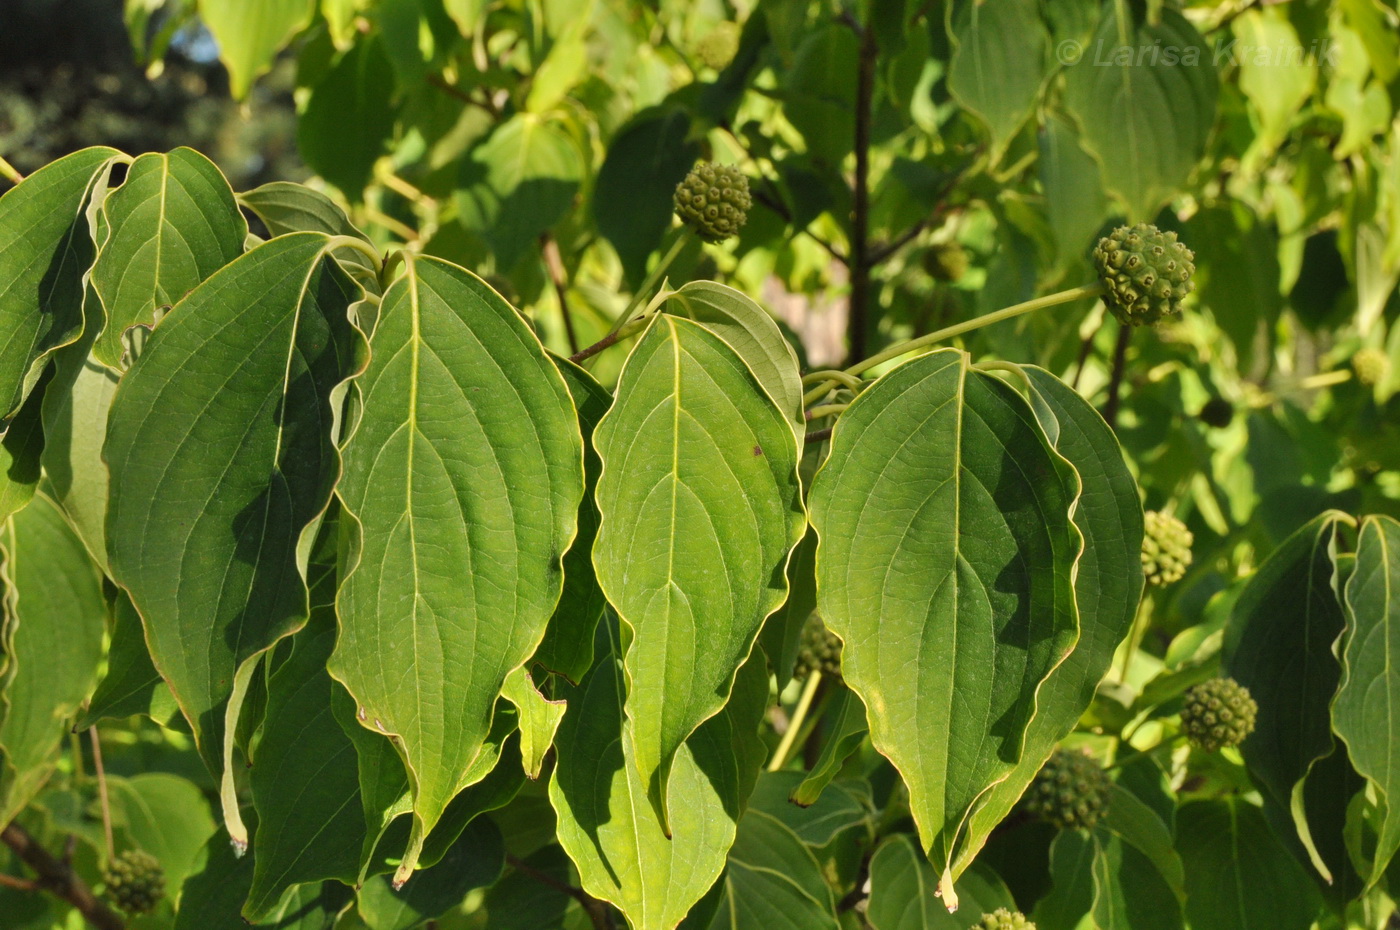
[{"x1": 0, "y1": 0, "x2": 1400, "y2": 930}]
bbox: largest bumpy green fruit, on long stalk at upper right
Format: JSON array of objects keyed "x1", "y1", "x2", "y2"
[{"x1": 1093, "y1": 223, "x2": 1196, "y2": 326}]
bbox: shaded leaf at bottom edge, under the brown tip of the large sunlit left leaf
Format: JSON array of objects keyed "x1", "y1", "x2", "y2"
[{"x1": 358, "y1": 818, "x2": 505, "y2": 930}]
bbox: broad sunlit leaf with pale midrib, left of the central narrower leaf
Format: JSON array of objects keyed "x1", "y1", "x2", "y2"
[{"x1": 330, "y1": 258, "x2": 584, "y2": 881}]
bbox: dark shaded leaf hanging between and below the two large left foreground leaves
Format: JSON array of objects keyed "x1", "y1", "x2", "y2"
[{"x1": 244, "y1": 549, "x2": 365, "y2": 922}]
